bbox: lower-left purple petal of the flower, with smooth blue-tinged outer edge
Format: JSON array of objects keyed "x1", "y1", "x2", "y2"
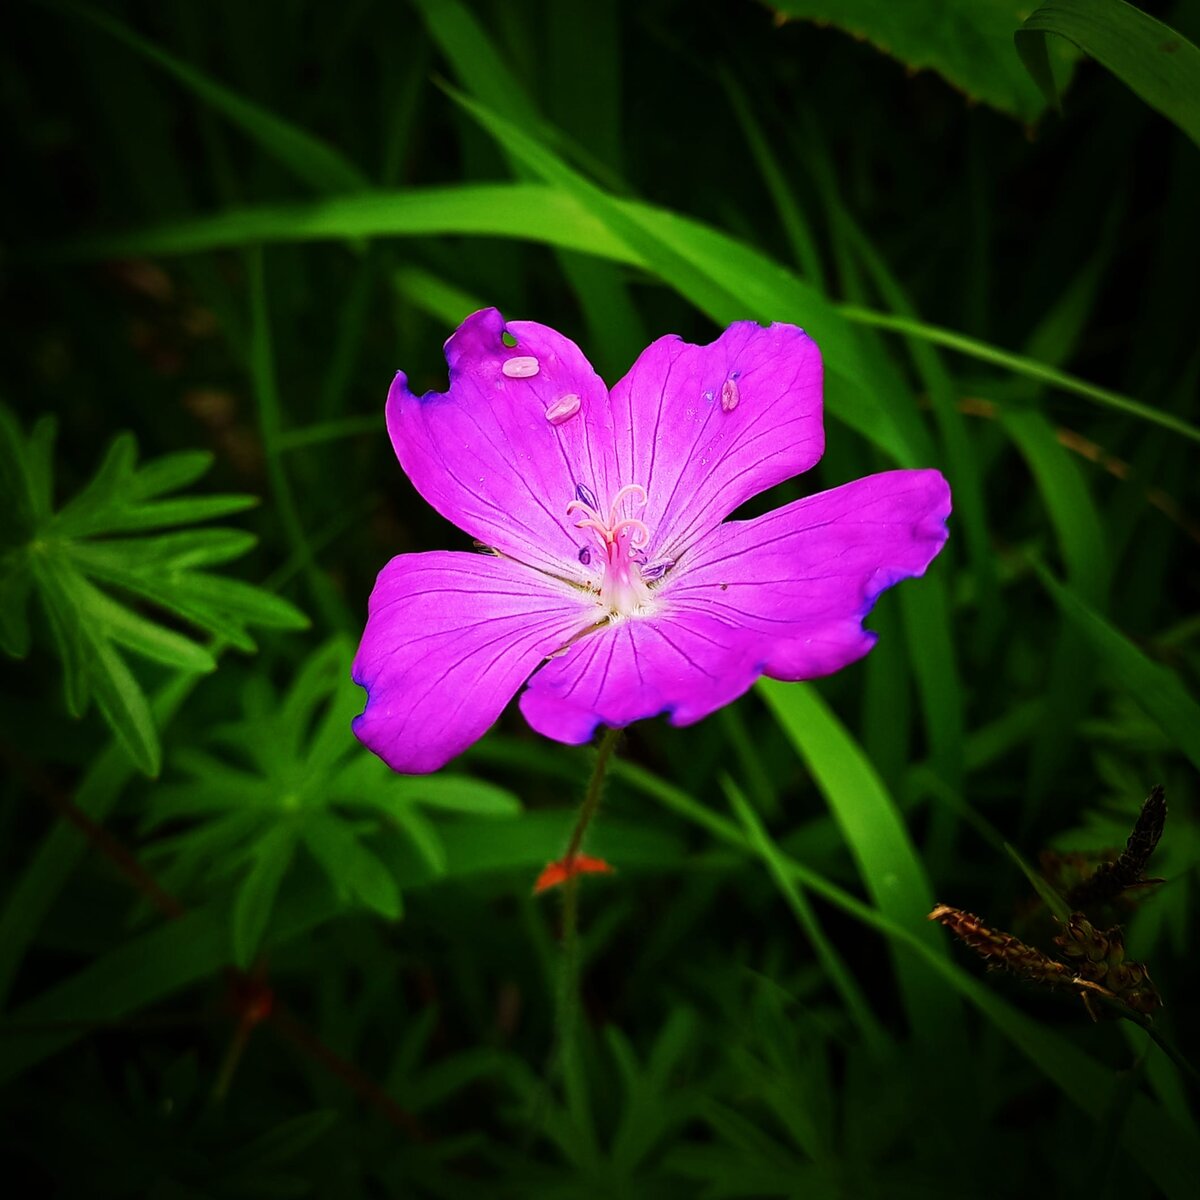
[{"x1": 352, "y1": 551, "x2": 596, "y2": 773}]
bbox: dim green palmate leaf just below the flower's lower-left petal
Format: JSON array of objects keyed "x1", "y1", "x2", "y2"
[{"x1": 142, "y1": 638, "x2": 521, "y2": 966}]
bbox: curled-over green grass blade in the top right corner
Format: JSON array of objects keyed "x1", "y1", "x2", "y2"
[{"x1": 1014, "y1": 0, "x2": 1200, "y2": 145}]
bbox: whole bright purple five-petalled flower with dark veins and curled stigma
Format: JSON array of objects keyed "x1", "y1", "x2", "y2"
[{"x1": 354, "y1": 308, "x2": 950, "y2": 772}]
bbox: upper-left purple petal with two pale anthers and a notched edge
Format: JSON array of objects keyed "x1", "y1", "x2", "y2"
[{"x1": 388, "y1": 308, "x2": 616, "y2": 582}]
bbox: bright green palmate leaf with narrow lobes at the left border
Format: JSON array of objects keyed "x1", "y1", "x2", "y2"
[{"x1": 0, "y1": 408, "x2": 307, "y2": 775}]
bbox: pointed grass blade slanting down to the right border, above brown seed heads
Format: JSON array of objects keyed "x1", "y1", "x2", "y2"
[{"x1": 1037, "y1": 566, "x2": 1200, "y2": 769}]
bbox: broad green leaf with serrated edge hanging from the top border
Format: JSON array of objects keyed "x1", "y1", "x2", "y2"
[{"x1": 769, "y1": 0, "x2": 1060, "y2": 121}]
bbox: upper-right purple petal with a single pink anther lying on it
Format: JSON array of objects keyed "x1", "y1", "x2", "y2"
[{"x1": 610, "y1": 320, "x2": 824, "y2": 560}]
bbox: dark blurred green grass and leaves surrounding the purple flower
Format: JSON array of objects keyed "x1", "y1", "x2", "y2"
[{"x1": 0, "y1": 0, "x2": 1200, "y2": 1200}]
